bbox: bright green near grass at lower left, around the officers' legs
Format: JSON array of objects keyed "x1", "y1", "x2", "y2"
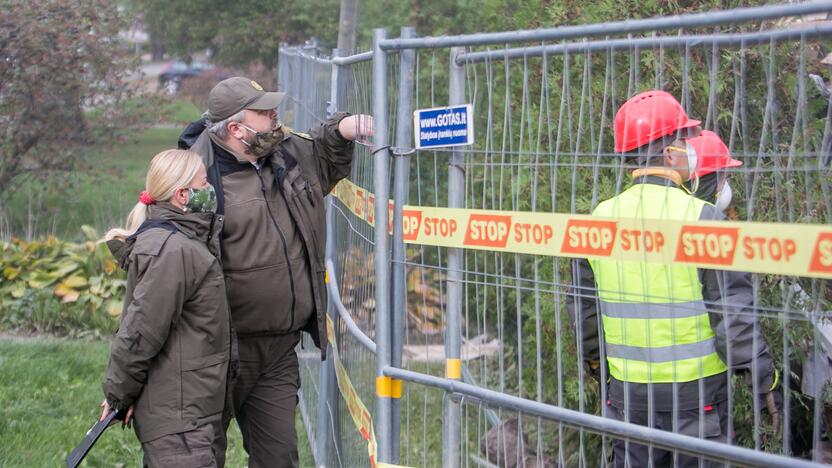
[{"x1": 0, "y1": 338, "x2": 314, "y2": 467}]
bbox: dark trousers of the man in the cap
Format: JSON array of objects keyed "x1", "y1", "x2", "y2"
[{"x1": 214, "y1": 332, "x2": 300, "y2": 468}]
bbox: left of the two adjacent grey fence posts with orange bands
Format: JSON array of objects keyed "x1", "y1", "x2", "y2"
[{"x1": 372, "y1": 28, "x2": 391, "y2": 463}]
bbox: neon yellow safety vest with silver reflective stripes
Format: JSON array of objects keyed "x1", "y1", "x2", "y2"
[{"x1": 590, "y1": 184, "x2": 726, "y2": 383}]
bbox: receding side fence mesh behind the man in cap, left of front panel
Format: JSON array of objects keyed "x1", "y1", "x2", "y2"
[{"x1": 278, "y1": 45, "x2": 384, "y2": 467}]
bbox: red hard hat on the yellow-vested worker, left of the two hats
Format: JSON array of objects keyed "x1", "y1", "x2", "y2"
[{"x1": 614, "y1": 90, "x2": 699, "y2": 153}]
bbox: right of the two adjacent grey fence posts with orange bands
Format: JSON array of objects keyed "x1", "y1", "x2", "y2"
[{"x1": 391, "y1": 26, "x2": 416, "y2": 463}]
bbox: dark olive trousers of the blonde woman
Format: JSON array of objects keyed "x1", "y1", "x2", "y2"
[{"x1": 142, "y1": 424, "x2": 217, "y2": 468}]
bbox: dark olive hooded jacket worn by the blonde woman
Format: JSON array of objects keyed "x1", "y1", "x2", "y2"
[{"x1": 103, "y1": 203, "x2": 231, "y2": 442}]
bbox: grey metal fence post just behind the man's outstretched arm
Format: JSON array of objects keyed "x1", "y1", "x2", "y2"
[{"x1": 315, "y1": 49, "x2": 339, "y2": 466}]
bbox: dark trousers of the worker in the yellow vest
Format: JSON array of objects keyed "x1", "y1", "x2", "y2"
[{"x1": 607, "y1": 402, "x2": 728, "y2": 468}]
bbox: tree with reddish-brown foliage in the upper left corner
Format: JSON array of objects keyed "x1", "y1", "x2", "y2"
[{"x1": 0, "y1": 0, "x2": 148, "y2": 194}]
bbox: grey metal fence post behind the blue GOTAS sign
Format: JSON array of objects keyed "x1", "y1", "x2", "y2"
[{"x1": 442, "y1": 47, "x2": 465, "y2": 467}]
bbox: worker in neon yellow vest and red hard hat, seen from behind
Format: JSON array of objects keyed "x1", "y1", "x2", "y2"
[{"x1": 568, "y1": 91, "x2": 780, "y2": 467}]
